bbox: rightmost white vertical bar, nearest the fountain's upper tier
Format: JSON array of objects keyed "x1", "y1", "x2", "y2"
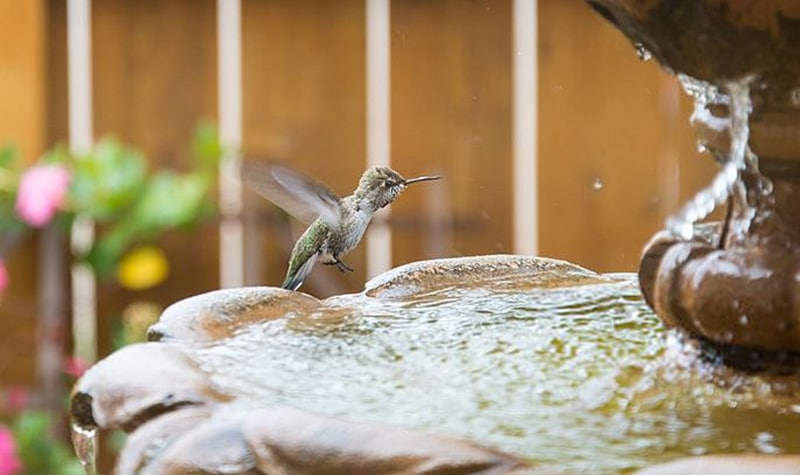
[{"x1": 512, "y1": 0, "x2": 539, "y2": 255}]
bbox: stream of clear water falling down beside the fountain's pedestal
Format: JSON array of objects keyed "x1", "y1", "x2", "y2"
[{"x1": 666, "y1": 74, "x2": 768, "y2": 240}]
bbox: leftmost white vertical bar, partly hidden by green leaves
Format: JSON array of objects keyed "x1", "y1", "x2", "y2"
[{"x1": 67, "y1": 0, "x2": 97, "y2": 362}]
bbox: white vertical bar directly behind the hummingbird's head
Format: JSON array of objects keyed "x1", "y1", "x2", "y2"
[{"x1": 366, "y1": 0, "x2": 392, "y2": 278}]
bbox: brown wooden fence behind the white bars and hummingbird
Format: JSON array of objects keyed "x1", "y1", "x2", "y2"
[{"x1": 0, "y1": 0, "x2": 714, "y2": 406}]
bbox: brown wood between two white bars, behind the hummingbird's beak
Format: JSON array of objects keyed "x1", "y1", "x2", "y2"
[{"x1": 392, "y1": 0, "x2": 512, "y2": 265}]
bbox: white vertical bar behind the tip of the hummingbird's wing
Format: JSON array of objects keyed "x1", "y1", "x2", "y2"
[{"x1": 217, "y1": 0, "x2": 244, "y2": 288}]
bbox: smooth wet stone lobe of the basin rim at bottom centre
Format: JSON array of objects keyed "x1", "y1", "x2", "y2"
[{"x1": 243, "y1": 407, "x2": 541, "y2": 475}]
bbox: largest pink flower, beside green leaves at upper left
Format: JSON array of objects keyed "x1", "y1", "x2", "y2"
[{"x1": 16, "y1": 165, "x2": 70, "y2": 228}]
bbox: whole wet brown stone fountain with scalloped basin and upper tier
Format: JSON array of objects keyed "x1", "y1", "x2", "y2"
[{"x1": 70, "y1": 0, "x2": 800, "y2": 475}]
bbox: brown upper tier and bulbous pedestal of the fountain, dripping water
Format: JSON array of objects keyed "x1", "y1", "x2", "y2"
[{"x1": 587, "y1": 0, "x2": 800, "y2": 369}]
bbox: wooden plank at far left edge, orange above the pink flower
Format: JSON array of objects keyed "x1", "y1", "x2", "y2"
[{"x1": 0, "y1": 0, "x2": 47, "y2": 385}]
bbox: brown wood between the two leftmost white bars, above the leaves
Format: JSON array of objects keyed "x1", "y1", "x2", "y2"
[{"x1": 92, "y1": 0, "x2": 217, "y2": 166}]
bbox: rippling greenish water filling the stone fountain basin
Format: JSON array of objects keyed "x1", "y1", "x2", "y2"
[{"x1": 181, "y1": 274, "x2": 800, "y2": 473}]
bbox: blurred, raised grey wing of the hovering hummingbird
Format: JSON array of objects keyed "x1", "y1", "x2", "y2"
[{"x1": 242, "y1": 160, "x2": 339, "y2": 227}]
